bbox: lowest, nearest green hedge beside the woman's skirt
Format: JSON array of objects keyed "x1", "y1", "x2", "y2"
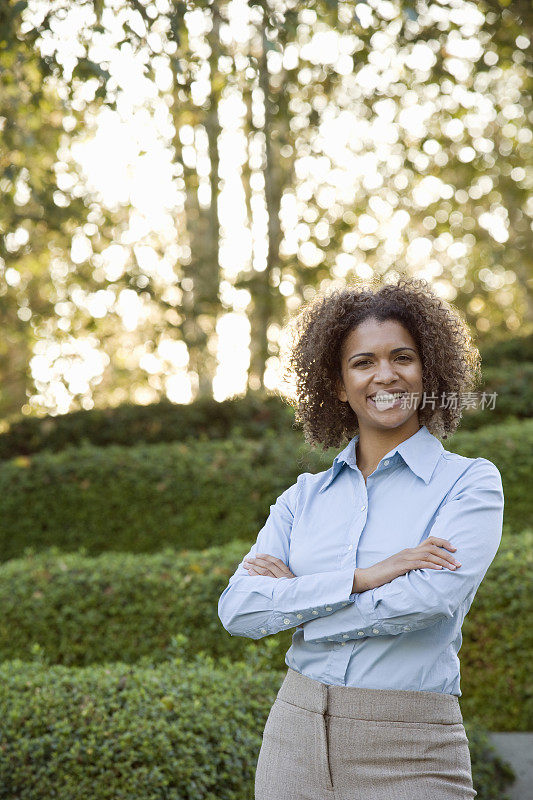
[{"x1": 0, "y1": 657, "x2": 515, "y2": 800}]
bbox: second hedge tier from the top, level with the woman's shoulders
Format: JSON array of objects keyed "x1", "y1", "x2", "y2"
[{"x1": 0, "y1": 420, "x2": 533, "y2": 561}]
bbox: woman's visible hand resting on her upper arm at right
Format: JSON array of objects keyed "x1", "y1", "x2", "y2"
[{"x1": 352, "y1": 536, "x2": 461, "y2": 592}]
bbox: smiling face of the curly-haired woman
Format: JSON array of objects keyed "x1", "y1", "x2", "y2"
[{"x1": 338, "y1": 318, "x2": 423, "y2": 433}]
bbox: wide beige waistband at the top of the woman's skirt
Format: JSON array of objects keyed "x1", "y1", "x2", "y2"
[{"x1": 277, "y1": 667, "x2": 463, "y2": 725}]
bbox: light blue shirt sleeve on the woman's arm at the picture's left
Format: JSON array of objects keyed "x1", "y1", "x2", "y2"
[{"x1": 218, "y1": 473, "x2": 354, "y2": 639}]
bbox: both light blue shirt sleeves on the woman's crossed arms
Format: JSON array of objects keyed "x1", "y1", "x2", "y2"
[{"x1": 219, "y1": 459, "x2": 504, "y2": 642}]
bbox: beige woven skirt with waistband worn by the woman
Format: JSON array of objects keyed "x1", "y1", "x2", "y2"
[{"x1": 255, "y1": 667, "x2": 477, "y2": 800}]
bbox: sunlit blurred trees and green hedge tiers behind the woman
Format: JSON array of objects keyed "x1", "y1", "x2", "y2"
[{"x1": 0, "y1": 0, "x2": 533, "y2": 800}]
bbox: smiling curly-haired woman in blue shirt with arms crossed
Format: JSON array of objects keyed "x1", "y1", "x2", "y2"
[{"x1": 219, "y1": 279, "x2": 504, "y2": 800}]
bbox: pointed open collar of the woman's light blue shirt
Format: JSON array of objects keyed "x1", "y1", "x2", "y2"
[{"x1": 319, "y1": 425, "x2": 444, "y2": 493}]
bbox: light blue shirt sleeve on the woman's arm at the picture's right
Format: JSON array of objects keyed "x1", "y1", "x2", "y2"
[{"x1": 303, "y1": 458, "x2": 504, "y2": 642}]
